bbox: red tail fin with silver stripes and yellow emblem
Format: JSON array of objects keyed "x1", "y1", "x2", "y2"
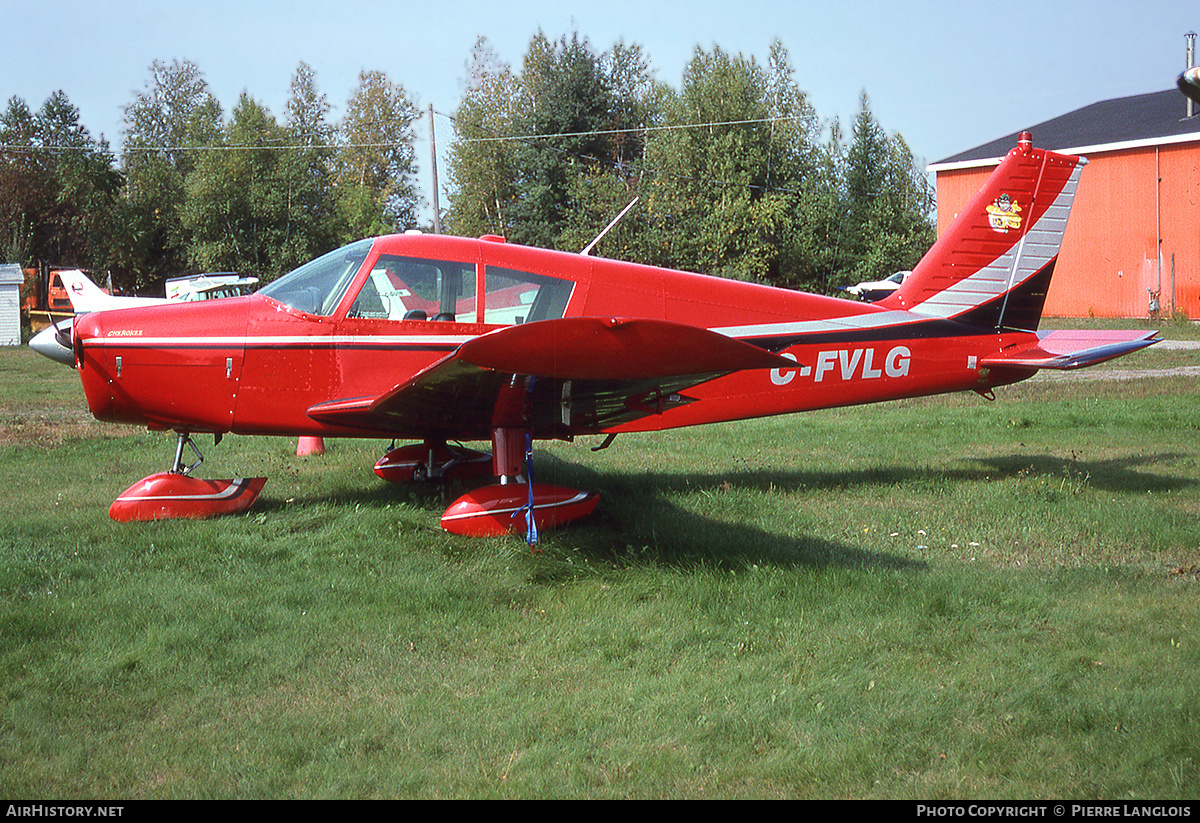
[{"x1": 881, "y1": 133, "x2": 1087, "y2": 331}]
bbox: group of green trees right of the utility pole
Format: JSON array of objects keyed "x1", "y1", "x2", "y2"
[{"x1": 448, "y1": 32, "x2": 932, "y2": 290}]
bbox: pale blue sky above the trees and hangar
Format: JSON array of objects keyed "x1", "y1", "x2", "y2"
[{"x1": 0, "y1": 0, "x2": 1200, "y2": 219}]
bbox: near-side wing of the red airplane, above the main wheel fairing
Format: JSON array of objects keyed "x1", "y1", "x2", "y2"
[{"x1": 308, "y1": 318, "x2": 793, "y2": 440}]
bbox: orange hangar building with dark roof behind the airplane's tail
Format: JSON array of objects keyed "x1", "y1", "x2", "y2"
[{"x1": 929, "y1": 89, "x2": 1200, "y2": 319}]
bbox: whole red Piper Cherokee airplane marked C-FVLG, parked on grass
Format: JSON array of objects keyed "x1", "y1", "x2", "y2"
[{"x1": 60, "y1": 134, "x2": 1158, "y2": 542}]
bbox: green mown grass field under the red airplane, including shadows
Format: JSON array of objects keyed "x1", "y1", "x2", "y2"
[{"x1": 0, "y1": 326, "x2": 1200, "y2": 799}]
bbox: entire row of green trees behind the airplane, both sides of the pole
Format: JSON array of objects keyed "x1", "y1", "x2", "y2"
[{"x1": 0, "y1": 38, "x2": 934, "y2": 298}]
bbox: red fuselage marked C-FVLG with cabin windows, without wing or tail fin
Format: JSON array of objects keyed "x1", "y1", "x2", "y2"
[{"x1": 74, "y1": 235, "x2": 1032, "y2": 439}]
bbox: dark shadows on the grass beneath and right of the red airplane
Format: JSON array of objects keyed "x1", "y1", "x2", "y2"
[{"x1": 258, "y1": 443, "x2": 1196, "y2": 571}]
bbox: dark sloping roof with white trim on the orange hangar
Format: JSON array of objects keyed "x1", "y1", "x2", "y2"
[{"x1": 929, "y1": 89, "x2": 1200, "y2": 172}]
